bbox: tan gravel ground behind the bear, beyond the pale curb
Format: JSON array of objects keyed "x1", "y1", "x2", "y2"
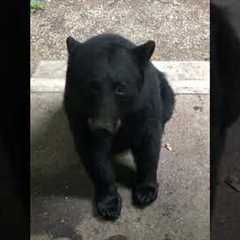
[{"x1": 31, "y1": 0, "x2": 209, "y2": 72}]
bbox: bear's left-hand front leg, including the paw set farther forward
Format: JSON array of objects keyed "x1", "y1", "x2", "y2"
[{"x1": 75, "y1": 132, "x2": 121, "y2": 220}]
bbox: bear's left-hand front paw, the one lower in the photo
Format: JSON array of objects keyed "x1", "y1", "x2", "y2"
[{"x1": 96, "y1": 192, "x2": 122, "y2": 220}]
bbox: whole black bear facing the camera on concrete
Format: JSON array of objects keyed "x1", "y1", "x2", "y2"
[{"x1": 64, "y1": 34, "x2": 175, "y2": 220}]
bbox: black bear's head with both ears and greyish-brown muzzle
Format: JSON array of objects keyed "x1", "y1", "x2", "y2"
[{"x1": 66, "y1": 36, "x2": 155, "y2": 133}]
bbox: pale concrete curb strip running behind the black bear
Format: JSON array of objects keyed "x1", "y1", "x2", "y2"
[{"x1": 31, "y1": 61, "x2": 209, "y2": 94}]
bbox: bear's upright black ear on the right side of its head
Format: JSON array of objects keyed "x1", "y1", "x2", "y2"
[{"x1": 133, "y1": 40, "x2": 155, "y2": 64}]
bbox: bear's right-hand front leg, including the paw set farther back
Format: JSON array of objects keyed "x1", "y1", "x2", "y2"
[{"x1": 132, "y1": 119, "x2": 163, "y2": 207}]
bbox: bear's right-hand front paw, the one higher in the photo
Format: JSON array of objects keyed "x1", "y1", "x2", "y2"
[{"x1": 133, "y1": 184, "x2": 158, "y2": 208}]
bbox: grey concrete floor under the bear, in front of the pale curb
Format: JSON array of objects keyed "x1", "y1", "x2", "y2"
[{"x1": 31, "y1": 63, "x2": 210, "y2": 240}]
